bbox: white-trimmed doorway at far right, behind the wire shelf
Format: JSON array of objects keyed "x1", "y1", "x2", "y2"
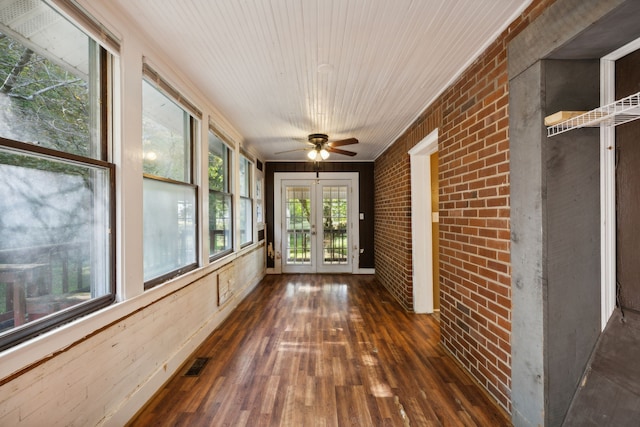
[{"x1": 600, "y1": 39, "x2": 640, "y2": 329}]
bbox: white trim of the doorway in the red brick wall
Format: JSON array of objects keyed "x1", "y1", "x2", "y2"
[{"x1": 409, "y1": 129, "x2": 438, "y2": 313}]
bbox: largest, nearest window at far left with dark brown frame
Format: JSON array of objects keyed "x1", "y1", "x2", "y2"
[{"x1": 0, "y1": 1, "x2": 115, "y2": 350}]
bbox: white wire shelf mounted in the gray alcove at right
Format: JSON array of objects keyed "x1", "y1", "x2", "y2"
[{"x1": 545, "y1": 92, "x2": 640, "y2": 137}]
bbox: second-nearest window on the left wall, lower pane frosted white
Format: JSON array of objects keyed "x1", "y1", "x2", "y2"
[{"x1": 142, "y1": 80, "x2": 197, "y2": 288}]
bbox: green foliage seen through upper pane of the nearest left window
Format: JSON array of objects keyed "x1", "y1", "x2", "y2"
[{"x1": 0, "y1": 33, "x2": 96, "y2": 157}]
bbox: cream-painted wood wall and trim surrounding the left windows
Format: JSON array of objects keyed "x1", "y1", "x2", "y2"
[{"x1": 0, "y1": 0, "x2": 265, "y2": 427}]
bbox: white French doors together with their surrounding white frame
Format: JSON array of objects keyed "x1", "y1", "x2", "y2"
[{"x1": 274, "y1": 173, "x2": 359, "y2": 273}]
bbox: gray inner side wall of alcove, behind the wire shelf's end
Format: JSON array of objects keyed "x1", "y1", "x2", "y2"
[{"x1": 542, "y1": 60, "x2": 601, "y2": 426}]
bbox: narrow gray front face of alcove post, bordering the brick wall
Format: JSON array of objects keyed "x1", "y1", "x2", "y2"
[{"x1": 509, "y1": 62, "x2": 547, "y2": 426}]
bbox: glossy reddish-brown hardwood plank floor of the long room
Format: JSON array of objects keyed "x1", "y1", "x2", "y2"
[{"x1": 130, "y1": 275, "x2": 510, "y2": 426}]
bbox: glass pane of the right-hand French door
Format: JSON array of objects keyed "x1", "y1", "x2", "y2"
[{"x1": 322, "y1": 185, "x2": 349, "y2": 265}]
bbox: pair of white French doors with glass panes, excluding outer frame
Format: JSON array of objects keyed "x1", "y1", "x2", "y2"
[{"x1": 280, "y1": 179, "x2": 353, "y2": 273}]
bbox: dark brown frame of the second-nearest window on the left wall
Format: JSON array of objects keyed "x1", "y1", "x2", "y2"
[{"x1": 141, "y1": 72, "x2": 202, "y2": 291}]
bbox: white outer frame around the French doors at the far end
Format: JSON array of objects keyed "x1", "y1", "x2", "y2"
[{"x1": 273, "y1": 172, "x2": 360, "y2": 274}]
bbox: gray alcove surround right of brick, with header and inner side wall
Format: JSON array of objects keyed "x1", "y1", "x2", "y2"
[{"x1": 509, "y1": 0, "x2": 640, "y2": 426}]
